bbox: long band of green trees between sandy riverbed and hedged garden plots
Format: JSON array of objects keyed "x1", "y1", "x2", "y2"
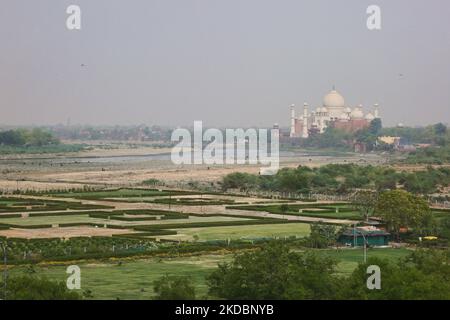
[{"x1": 221, "y1": 164, "x2": 450, "y2": 194}]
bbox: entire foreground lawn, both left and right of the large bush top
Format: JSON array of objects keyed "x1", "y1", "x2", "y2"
[{"x1": 10, "y1": 249, "x2": 409, "y2": 299}]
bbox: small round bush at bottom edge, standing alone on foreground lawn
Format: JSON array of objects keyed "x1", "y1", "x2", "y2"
[{"x1": 153, "y1": 275, "x2": 195, "y2": 300}]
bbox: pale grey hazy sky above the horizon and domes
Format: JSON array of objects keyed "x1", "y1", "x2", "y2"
[{"x1": 0, "y1": 0, "x2": 450, "y2": 126}]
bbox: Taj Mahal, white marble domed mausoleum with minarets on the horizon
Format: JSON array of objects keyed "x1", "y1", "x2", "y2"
[{"x1": 289, "y1": 87, "x2": 380, "y2": 138}]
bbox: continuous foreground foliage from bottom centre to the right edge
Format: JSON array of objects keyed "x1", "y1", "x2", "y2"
[{"x1": 208, "y1": 243, "x2": 450, "y2": 300}]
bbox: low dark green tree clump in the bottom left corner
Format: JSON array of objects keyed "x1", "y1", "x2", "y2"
[{"x1": 1, "y1": 275, "x2": 82, "y2": 300}]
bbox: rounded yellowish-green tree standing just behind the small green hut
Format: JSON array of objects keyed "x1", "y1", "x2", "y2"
[{"x1": 375, "y1": 190, "x2": 431, "y2": 237}]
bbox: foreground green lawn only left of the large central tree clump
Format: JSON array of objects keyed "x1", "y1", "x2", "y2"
[{"x1": 6, "y1": 255, "x2": 225, "y2": 299}]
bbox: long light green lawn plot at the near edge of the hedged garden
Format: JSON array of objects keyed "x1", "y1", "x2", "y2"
[{"x1": 162, "y1": 223, "x2": 309, "y2": 241}]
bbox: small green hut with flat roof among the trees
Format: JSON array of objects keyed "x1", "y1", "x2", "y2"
[{"x1": 338, "y1": 228, "x2": 390, "y2": 247}]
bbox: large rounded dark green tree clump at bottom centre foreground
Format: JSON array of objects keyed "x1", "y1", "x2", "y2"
[{"x1": 207, "y1": 242, "x2": 338, "y2": 300}]
